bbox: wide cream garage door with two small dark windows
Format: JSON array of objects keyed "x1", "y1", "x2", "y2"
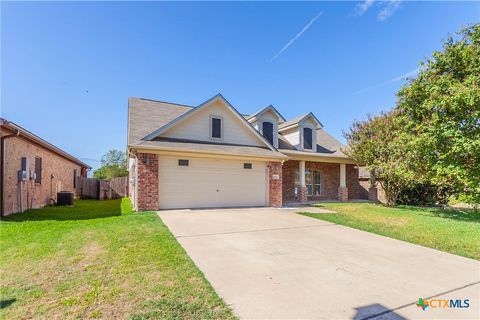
[{"x1": 158, "y1": 157, "x2": 268, "y2": 209}]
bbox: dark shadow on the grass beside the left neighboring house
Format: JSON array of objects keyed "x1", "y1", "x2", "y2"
[{"x1": 2, "y1": 198, "x2": 132, "y2": 222}]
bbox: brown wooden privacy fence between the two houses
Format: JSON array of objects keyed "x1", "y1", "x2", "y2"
[{"x1": 75, "y1": 177, "x2": 128, "y2": 200}]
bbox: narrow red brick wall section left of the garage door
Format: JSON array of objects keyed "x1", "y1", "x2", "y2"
[{"x1": 136, "y1": 153, "x2": 158, "y2": 211}]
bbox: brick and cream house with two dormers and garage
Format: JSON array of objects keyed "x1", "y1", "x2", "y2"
[{"x1": 127, "y1": 94, "x2": 359, "y2": 210}]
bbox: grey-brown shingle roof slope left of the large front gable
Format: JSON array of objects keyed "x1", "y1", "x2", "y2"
[{"x1": 127, "y1": 97, "x2": 193, "y2": 145}]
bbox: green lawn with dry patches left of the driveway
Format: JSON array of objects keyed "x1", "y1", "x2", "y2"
[{"x1": 0, "y1": 199, "x2": 234, "y2": 319}]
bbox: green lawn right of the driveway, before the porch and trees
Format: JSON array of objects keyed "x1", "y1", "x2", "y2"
[{"x1": 302, "y1": 203, "x2": 480, "y2": 260}]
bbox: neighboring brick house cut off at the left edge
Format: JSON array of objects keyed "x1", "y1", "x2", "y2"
[{"x1": 0, "y1": 118, "x2": 91, "y2": 216}]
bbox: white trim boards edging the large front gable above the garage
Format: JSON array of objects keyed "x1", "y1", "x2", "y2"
[{"x1": 142, "y1": 93, "x2": 276, "y2": 151}]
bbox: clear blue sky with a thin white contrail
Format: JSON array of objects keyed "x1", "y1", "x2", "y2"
[{"x1": 1, "y1": 0, "x2": 480, "y2": 171}]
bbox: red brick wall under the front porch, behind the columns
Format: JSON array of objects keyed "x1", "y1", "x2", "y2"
[{"x1": 283, "y1": 160, "x2": 359, "y2": 202}]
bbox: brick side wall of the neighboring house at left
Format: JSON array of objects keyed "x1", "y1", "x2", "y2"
[{"x1": 3, "y1": 136, "x2": 81, "y2": 215}]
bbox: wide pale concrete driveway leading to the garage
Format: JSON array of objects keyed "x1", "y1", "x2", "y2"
[{"x1": 159, "y1": 208, "x2": 480, "y2": 319}]
